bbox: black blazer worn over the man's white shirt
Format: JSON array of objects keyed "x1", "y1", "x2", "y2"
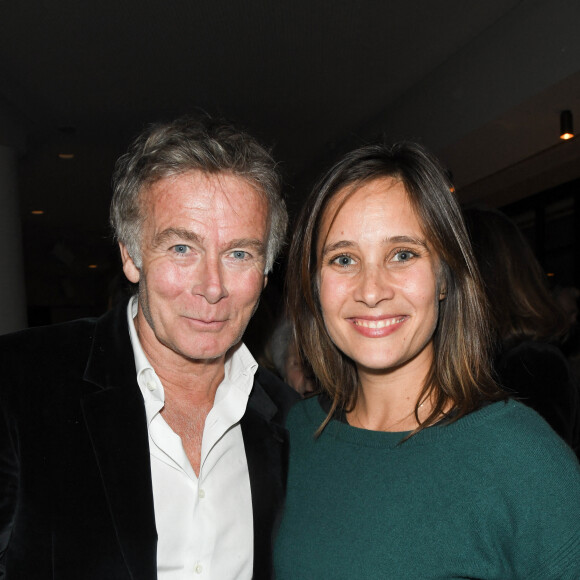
[{"x1": 0, "y1": 303, "x2": 297, "y2": 580}]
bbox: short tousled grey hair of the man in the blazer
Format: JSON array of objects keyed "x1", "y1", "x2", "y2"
[{"x1": 110, "y1": 116, "x2": 288, "y2": 273}]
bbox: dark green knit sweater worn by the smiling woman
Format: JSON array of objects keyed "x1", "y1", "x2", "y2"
[{"x1": 274, "y1": 398, "x2": 580, "y2": 580}]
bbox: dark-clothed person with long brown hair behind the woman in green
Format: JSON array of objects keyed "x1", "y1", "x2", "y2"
[{"x1": 463, "y1": 208, "x2": 580, "y2": 456}]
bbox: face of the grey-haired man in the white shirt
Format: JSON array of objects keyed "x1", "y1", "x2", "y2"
[{"x1": 121, "y1": 171, "x2": 268, "y2": 362}]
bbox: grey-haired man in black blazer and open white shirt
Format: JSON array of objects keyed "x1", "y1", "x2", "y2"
[{"x1": 0, "y1": 119, "x2": 296, "y2": 580}]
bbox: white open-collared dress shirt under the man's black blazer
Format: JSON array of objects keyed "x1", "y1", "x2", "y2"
[{"x1": 127, "y1": 297, "x2": 258, "y2": 580}]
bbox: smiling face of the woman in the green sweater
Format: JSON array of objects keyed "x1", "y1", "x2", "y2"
[{"x1": 317, "y1": 178, "x2": 442, "y2": 376}]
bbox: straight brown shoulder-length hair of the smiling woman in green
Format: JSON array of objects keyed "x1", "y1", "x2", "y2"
[{"x1": 287, "y1": 143, "x2": 506, "y2": 431}]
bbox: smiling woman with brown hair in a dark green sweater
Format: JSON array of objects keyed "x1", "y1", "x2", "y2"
[{"x1": 275, "y1": 144, "x2": 580, "y2": 580}]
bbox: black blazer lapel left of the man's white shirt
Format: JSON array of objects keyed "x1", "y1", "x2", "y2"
[{"x1": 82, "y1": 302, "x2": 157, "y2": 580}]
